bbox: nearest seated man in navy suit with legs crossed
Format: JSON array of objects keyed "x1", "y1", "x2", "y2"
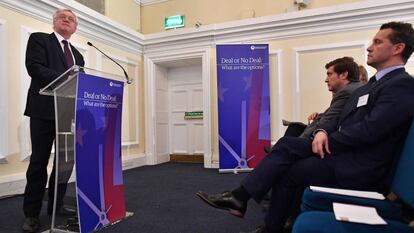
[{"x1": 197, "y1": 22, "x2": 414, "y2": 233}]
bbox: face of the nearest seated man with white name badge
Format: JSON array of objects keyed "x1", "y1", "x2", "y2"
[{"x1": 367, "y1": 28, "x2": 396, "y2": 70}]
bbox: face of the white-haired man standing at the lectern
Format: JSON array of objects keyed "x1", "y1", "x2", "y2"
[{"x1": 53, "y1": 11, "x2": 76, "y2": 39}]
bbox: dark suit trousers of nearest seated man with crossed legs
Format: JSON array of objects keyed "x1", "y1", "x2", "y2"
[{"x1": 242, "y1": 137, "x2": 339, "y2": 232}]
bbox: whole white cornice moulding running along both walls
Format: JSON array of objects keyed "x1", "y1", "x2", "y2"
[{"x1": 0, "y1": 0, "x2": 414, "y2": 54}]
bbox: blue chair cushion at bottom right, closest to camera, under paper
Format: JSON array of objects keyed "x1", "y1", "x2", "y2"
[{"x1": 292, "y1": 211, "x2": 414, "y2": 233}]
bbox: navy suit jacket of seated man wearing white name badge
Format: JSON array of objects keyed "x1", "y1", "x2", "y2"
[{"x1": 321, "y1": 68, "x2": 414, "y2": 188}]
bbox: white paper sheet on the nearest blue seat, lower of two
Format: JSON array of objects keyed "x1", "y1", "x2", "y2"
[{"x1": 333, "y1": 202, "x2": 387, "y2": 225}]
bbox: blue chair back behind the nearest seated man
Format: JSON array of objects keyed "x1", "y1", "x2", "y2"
[{"x1": 391, "y1": 119, "x2": 414, "y2": 208}]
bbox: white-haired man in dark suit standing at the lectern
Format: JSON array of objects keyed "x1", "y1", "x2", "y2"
[{"x1": 22, "y1": 9, "x2": 85, "y2": 232}]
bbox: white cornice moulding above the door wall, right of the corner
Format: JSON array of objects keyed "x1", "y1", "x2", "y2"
[{"x1": 145, "y1": 0, "x2": 414, "y2": 53}]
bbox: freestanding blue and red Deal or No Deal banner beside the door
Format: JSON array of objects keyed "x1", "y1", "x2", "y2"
[{"x1": 217, "y1": 44, "x2": 270, "y2": 172}]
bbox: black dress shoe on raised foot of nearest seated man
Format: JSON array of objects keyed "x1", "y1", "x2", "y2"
[{"x1": 196, "y1": 191, "x2": 247, "y2": 218}]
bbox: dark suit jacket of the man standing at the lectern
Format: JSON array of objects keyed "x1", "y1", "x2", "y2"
[{"x1": 24, "y1": 32, "x2": 85, "y2": 120}]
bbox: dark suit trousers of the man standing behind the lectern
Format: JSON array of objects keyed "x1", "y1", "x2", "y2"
[{"x1": 23, "y1": 117, "x2": 67, "y2": 217}]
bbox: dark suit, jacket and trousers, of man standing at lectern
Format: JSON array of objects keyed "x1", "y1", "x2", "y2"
[{"x1": 23, "y1": 33, "x2": 85, "y2": 217}]
